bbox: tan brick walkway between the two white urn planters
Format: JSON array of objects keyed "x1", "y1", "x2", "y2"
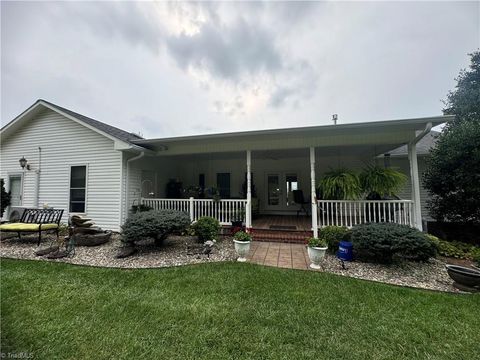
[{"x1": 247, "y1": 241, "x2": 310, "y2": 270}]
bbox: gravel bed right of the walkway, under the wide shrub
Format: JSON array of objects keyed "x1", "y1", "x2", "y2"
[{"x1": 321, "y1": 255, "x2": 460, "y2": 292}]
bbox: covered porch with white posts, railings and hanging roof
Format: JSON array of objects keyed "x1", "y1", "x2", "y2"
[{"x1": 126, "y1": 117, "x2": 443, "y2": 236}]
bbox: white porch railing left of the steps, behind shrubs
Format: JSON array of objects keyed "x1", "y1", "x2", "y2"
[{"x1": 141, "y1": 198, "x2": 247, "y2": 225}]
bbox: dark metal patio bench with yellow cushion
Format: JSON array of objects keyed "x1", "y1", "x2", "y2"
[{"x1": 0, "y1": 209, "x2": 63, "y2": 245}]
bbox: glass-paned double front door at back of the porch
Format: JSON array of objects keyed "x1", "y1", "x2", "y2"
[{"x1": 265, "y1": 172, "x2": 298, "y2": 211}]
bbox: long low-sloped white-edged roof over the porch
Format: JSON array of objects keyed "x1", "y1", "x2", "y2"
[{"x1": 132, "y1": 116, "x2": 454, "y2": 156}]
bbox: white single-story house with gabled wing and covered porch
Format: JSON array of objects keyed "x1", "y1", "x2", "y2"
[{"x1": 0, "y1": 100, "x2": 451, "y2": 234}]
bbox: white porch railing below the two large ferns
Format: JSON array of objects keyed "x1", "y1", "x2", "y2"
[{"x1": 317, "y1": 200, "x2": 413, "y2": 227}]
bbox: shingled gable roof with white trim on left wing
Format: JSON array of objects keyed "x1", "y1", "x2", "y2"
[{"x1": 1, "y1": 99, "x2": 143, "y2": 146}]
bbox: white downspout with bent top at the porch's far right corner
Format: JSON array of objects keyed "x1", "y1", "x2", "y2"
[{"x1": 408, "y1": 122, "x2": 432, "y2": 230}]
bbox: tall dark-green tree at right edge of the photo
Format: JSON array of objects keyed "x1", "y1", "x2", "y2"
[{"x1": 423, "y1": 51, "x2": 480, "y2": 223}]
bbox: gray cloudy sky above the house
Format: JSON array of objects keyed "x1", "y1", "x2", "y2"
[{"x1": 1, "y1": 1, "x2": 480, "y2": 137}]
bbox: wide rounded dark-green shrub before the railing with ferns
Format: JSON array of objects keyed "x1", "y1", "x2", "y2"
[{"x1": 350, "y1": 223, "x2": 435, "y2": 263}]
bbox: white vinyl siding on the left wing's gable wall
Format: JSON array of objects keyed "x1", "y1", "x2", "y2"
[{"x1": 0, "y1": 110, "x2": 122, "y2": 231}]
